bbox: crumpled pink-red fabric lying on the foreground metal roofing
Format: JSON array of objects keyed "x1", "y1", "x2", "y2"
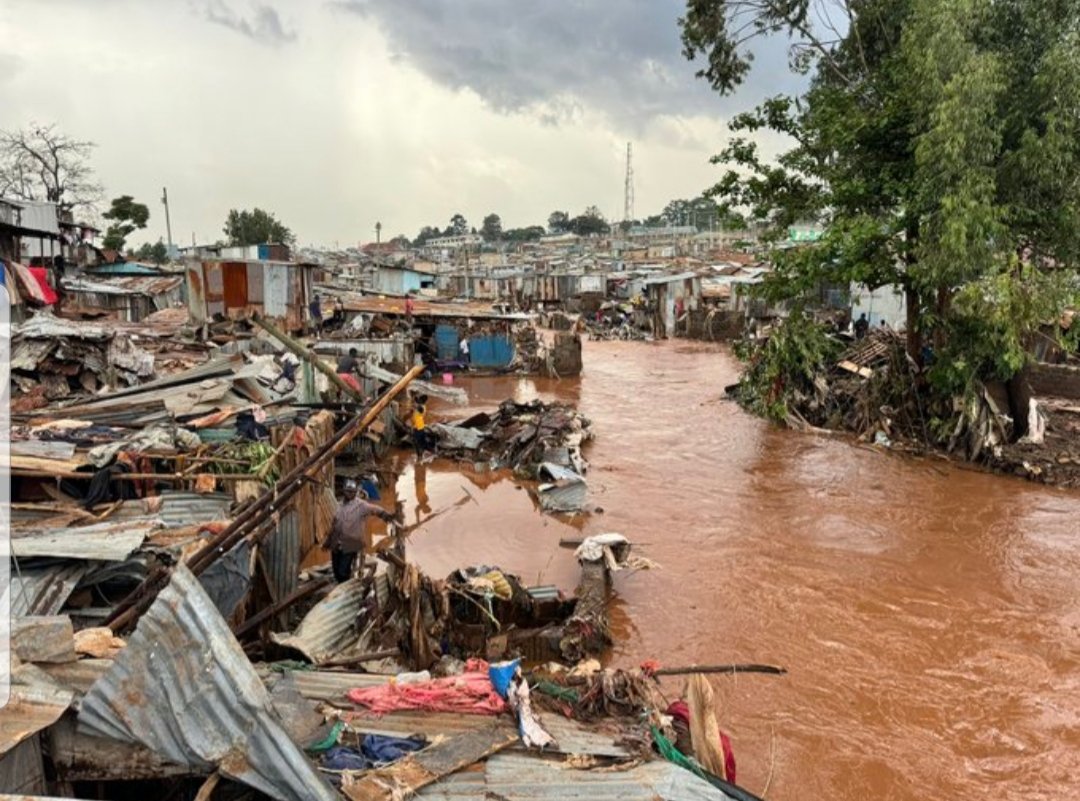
[{"x1": 348, "y1": 660, "x2": 508, "y2": 715}]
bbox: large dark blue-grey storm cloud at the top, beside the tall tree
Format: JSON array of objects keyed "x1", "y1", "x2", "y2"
[{"x1": 334, "y1": 0, "x2": 798, "y2": 124}]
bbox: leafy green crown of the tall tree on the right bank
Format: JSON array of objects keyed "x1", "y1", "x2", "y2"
[{"x1": 680, "y1": 0, "x2": 1080, "y2": 396}]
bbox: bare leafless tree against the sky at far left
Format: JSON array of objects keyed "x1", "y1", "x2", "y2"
[{"x1": 0, "y1": 123, "x2": 103, "y2": 212}]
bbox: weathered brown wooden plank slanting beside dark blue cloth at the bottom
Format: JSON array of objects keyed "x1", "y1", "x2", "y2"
[{"x1": 341, "y1": 718, "x2": 517, "y2": 801}]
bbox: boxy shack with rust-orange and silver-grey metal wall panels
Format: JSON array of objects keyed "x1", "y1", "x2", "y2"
[{"x1": 185, "y1": 259, "x2": 320, "y2": 331}]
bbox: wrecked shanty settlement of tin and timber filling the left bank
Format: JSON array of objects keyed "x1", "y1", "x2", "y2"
[{"x1": 0, "y1": 203, "x2": 783, "y2": 801}]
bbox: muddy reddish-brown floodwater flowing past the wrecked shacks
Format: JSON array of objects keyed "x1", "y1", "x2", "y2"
[{"x1": 380, "y1": 342, "x2": 1080, "y2": 801}]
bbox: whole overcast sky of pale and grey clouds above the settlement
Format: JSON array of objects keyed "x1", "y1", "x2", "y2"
[{"x1": 0, "y1": 0, "x2": 792, "y2": 246}]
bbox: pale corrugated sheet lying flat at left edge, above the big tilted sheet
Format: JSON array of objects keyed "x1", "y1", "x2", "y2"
[{"x1": 11, "y1": 517, "x2": 162, "y2": 561}]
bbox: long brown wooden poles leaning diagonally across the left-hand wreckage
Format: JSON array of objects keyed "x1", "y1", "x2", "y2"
[{"x1": 107, "y1": 366, "x2": 423, "y2": 632}]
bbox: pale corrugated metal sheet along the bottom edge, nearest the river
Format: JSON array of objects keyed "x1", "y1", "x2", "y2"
[{"x1": 417, "y1": 754, "x2": 731, "y2": 801}]
